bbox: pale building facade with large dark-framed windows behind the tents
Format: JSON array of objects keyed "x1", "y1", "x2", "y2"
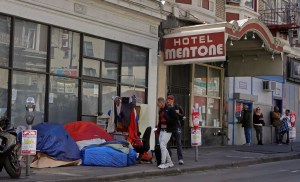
[{"x1": 0, "y1": 0, "x2": 166, "y2": 149}]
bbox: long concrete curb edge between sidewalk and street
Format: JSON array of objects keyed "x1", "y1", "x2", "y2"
[{"x1": 47, "y1": 153, "x2": 300, "y2": 182}]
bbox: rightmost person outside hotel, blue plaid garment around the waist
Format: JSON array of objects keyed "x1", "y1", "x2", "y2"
[{"x1": 279, "y1": 109, "x2": 291, "y2": 145}]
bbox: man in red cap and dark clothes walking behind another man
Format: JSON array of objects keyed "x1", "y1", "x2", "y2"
[{"x1": 167, "y1": 95, "x2": 184, "y2": 165}]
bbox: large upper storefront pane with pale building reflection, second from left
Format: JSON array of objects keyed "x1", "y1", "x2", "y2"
[{"x1": 13, "y1": 19, "x2": 48, "y2": 72}]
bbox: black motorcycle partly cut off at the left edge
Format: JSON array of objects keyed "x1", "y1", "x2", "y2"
[{"x1": 0, "y1": 117, "x2": 21, "y2": 179}]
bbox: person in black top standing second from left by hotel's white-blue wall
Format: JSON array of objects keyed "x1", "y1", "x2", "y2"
[{"x1": 253, "y1": 107, "x2": 265, "y2": 145}]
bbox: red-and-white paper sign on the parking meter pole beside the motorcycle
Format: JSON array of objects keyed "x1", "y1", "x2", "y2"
[{"x1": 21, "y1": 130, "x2": 37, "y2": 155}]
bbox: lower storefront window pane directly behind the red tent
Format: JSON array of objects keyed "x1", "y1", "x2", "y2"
[{"x1": 49, "y1": 76, "x2": 78, "y2": 124}]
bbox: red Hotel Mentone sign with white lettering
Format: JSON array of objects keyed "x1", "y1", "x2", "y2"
[{"x1": 163, "y1": 28, "x2": 225, "y2": 64}]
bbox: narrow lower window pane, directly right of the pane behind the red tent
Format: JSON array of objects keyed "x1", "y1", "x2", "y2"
[{"x1": 82, "y1": 82, "x2": 99, "y2": 116}]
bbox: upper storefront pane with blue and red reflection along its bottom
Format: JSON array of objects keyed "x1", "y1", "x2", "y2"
[{"x1": 50, "y1": 28, "x2": 80, "y2": 77}]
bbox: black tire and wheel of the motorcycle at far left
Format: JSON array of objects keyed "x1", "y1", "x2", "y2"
[{"x1": 4, "y1": 145, "x2": 21, "y2": 179}]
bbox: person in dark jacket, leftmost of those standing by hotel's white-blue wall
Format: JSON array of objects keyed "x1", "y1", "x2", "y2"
[{"x1": 241, "y1": 105, "x2": 252, "y2": 146}]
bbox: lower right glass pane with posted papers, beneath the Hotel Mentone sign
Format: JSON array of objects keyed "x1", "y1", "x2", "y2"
[{"x1": 207, "y1": 98, "x2": 220, "y2": 127}]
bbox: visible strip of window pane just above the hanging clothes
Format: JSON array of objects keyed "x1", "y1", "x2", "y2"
[{"x1": 121, "y1": 86, "x2": 145, "y2": 104}]
